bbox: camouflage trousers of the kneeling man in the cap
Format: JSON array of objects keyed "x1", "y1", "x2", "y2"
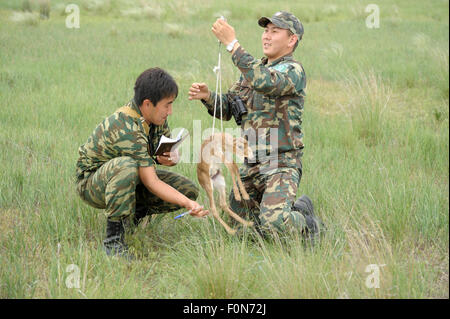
[{"x1": 230, "y1": 165, "x2": 306, "y2": 233}]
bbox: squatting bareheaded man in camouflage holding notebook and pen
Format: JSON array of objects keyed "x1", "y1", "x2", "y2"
[{"x1": 77, "y1": 68, "x2": 208, "y2": 255}]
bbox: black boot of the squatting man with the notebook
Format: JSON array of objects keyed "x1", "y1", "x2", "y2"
[{"x1": 103, "y1": 219, "x2": 132, "y2": 259}]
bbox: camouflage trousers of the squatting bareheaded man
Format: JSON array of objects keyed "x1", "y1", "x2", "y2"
[{"x1": 77, "y1": 156, "x2": 198, "y2": 221}]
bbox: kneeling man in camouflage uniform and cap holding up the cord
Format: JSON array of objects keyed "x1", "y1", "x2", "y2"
[{"x1": 189, "y1": 12, "x2": 322, "y2": 239}]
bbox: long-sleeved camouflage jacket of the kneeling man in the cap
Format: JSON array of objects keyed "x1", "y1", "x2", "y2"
[{"x1": 202, "y1": 47, "x2": 306, "y2": 167}]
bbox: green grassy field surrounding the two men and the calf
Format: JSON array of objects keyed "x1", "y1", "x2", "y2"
[{"x1": 0, "y1": 0, "x2": 449, "y2": 298}]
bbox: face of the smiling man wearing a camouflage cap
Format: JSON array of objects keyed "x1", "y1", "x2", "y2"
[{"x1": 261, "y1": 23, "x2": 296, "y2": 62}]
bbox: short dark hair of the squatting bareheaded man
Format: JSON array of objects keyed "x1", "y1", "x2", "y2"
[{"x1": 134, "y1": 68, "x2": 178, "y2": 106}]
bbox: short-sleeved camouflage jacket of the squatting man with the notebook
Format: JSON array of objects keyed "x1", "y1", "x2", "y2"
[{"x1": 76, "y1": 100, "x2": 170, "y2": 180}]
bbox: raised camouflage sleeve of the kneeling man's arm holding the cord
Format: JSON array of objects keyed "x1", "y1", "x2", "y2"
[{"x1": 232, "y1": 47, "x2": 306, "y2": 96}]
